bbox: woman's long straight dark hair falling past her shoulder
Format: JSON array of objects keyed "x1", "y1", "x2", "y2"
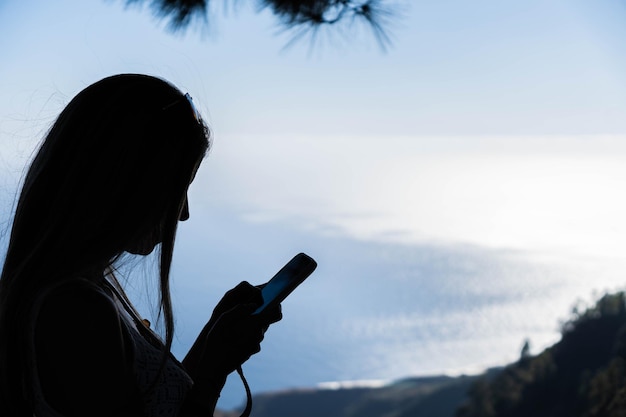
[{"x1": 0, "y1": 74, "x2": 209, "y2": 417}]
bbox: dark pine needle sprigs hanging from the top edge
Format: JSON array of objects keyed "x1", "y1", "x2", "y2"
[{"x1": 121, "y1": 0, "x2": 395, "y2": 48}]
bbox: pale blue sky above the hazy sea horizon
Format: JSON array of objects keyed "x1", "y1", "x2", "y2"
[{"x1": 0, "y1": 1, "x2": 626, "y2": 136}]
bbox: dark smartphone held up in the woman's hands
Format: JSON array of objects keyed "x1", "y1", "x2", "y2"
[{"x1": 252, "y1": 253, "x2": 317, "y2": 314}]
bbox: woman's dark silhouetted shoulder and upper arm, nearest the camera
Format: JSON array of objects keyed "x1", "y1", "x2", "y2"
[{"x1": 35, "y1": 280, "x2": 140, "y2": 415}]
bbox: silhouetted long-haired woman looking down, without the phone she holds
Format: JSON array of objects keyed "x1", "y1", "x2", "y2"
[{"x1": 0, "y1": 74, "x2": 281, "y2": 417}]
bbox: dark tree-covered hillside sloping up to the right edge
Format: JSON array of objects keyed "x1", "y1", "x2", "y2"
[{"x1": 457, "y1": 292, "x2": 626, "y2": 417}]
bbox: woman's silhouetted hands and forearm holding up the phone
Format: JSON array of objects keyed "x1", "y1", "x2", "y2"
[{"x1": 183, "y1": 282, "x2": 282, "y2": 389}]
